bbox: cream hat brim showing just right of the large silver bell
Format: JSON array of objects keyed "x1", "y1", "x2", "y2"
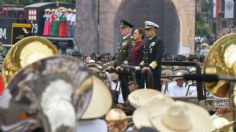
[{"x1": 81, "y1": 76, "x2": 112, "y2": 119}]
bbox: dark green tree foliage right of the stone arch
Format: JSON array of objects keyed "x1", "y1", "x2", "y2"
[{"x1": 195, "y1": 11, "x2": 211, "y2": 36}]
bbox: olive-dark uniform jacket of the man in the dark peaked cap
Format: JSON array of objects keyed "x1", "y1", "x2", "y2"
[{"x1": 115, "y1": 35, "x2": 134, "y2": 66}]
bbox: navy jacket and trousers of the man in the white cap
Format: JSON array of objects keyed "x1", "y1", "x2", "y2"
[{"x1": 140, "y1": 36, "x2": 164, "y2": 90}]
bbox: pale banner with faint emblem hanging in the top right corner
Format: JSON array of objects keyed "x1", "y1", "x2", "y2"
[{"x1": 225, "y1": 0, "x2": 234, "y2": 18}]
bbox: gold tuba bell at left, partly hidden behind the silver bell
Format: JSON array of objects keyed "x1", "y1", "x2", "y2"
[{"x1": 2, "y1": 36, "x2": 59, "y2": 84}]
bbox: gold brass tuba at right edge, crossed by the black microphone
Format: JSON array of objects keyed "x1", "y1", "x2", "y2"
[{"x1": 203, "y1": 33, "x2": 236, "y2": 97}]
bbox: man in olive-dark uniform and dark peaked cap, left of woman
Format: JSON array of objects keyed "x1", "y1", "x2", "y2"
[{"x1": 114, "y1": 20, "x2": 134, "y2": 101}]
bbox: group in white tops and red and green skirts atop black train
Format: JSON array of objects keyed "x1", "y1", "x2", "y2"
[{"x1": 43, "y1": 7, "x2": 76, "y2": 37}]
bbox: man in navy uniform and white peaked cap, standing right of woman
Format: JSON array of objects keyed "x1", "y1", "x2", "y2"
[{"x1": 140, "y1": 21, "x2": 164, "y2": 91}]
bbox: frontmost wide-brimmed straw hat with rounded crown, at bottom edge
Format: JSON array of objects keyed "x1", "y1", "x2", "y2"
[{"x1": 147, "y1": 101, "x2": 212, "y2": 132}]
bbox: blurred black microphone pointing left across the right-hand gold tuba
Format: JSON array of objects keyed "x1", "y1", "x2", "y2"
[{"x1": 183, "y1": 74, "x2": 236, "y2": 82}]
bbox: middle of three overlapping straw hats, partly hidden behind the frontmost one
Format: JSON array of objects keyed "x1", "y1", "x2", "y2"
[{"x1": 133, "y1": 94, "x2": 174, "y2": 129}]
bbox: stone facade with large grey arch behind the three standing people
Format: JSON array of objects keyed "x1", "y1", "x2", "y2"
[{"x1": 75, "y1": 0, "x2": 195, "y2": 55}]
